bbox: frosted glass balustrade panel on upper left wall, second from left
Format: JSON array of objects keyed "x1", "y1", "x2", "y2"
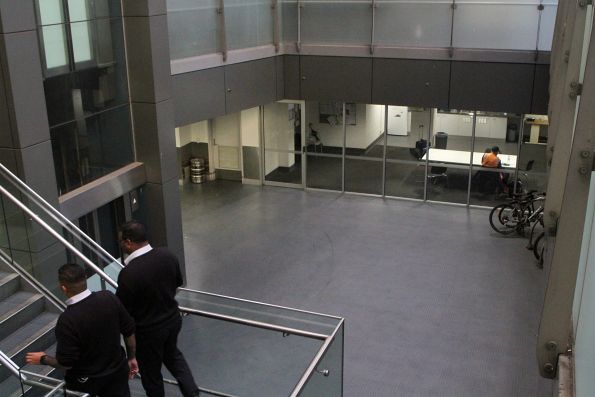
[{"x1": 225, "y1": 0, "x2": 273, "y2": 50}]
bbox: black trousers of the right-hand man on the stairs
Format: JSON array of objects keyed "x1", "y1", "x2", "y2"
[{"x1": 136, "y1": 317, "x2": 198, "y2": 397}]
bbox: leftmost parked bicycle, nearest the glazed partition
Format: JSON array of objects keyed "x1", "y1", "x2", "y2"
[{"x1": 490, "y1": 190, "x2": 545, "y2": 235}]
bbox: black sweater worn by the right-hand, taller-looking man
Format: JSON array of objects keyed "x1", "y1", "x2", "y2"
[{"x1": 116, "y1": 248, "x2": 182, "y2": 335}]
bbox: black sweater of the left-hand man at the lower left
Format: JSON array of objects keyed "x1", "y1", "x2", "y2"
[{"x1": 55, "y1": 291, "x2": 134, "y2": 379}]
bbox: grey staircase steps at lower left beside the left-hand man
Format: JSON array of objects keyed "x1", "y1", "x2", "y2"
[{"x1": 0, "y1": 263, "x2": 62, "y2": 397}]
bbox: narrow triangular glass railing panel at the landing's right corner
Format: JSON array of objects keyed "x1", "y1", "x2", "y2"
[{"x1": 298, "y1": 324, "x2": 344, "y2": 397}]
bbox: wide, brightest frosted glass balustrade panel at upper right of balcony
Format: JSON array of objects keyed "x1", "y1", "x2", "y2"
[{"x1": 452, "y1": 0, "x2": 539, "y2": 50}]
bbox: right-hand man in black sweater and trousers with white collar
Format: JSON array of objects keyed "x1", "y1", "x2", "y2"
[{"x1": 116, "y1": 221, "x2": 199, "y2": 397}]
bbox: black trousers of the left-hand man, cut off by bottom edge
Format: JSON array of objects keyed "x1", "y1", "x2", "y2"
[{"x1": 66, "y1": 360, "x2": 130, "y2": 397}]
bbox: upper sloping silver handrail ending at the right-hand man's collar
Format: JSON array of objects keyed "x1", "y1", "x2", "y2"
[{"x1": 0, "y1": 163, "x2": 123, "y2": 267}]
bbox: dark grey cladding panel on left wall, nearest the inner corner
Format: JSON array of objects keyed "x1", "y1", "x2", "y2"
[{"x1": 225, "y1": 57, "x2": 277, "y2": 114}]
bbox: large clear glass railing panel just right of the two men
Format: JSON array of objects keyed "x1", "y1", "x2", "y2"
[{"x1": 178, "y1": 315, "x2": 324, "y2": 397}]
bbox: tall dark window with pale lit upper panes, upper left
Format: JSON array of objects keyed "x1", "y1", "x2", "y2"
[{"x1": 36, "y1": 0, "x2": 134, "y2": 194}]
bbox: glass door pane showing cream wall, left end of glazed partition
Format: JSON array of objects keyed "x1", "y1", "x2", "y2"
[{"x1": 262, "y1": 101, "x2": 305, "y2": 188}]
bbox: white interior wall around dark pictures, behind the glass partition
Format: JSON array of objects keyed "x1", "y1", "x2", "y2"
[{"x1": 306, "y1": 101, "x2": 384, "y2": 149}]
